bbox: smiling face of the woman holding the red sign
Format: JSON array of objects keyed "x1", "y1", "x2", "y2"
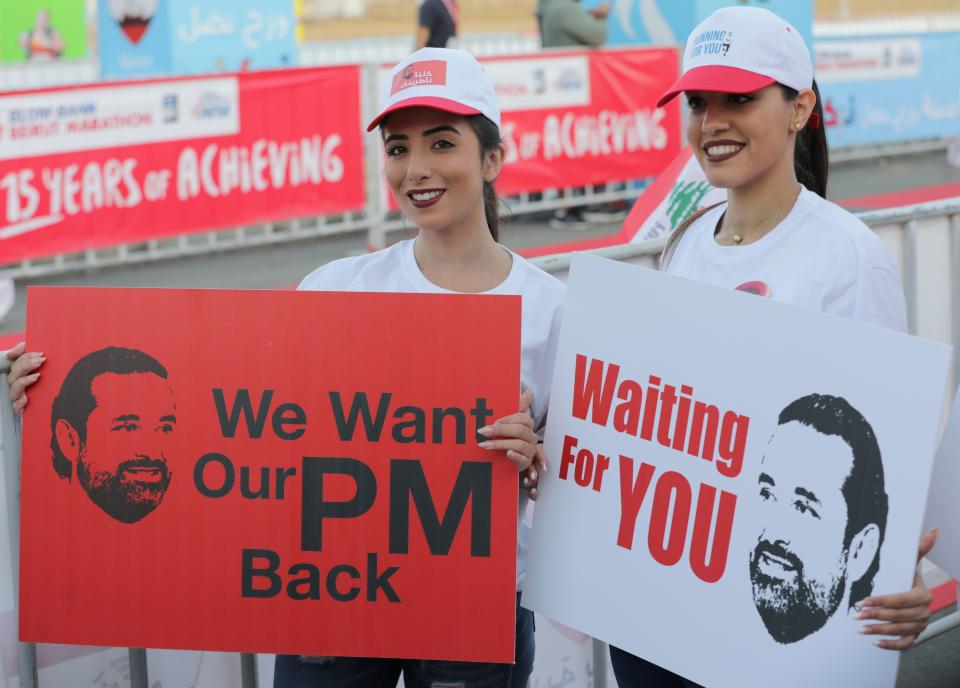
[{"x1": 381, "y1": 107, "x2": 501, "y2": 232}]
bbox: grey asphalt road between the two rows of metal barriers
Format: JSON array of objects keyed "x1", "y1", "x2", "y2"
[{"x1": 0, "y1": 152, "x2": 960, "y2": 335}]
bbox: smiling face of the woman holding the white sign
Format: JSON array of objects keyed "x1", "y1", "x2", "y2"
[{"x1": 685, "y1": 84, "x2": 812, "y2": 195}]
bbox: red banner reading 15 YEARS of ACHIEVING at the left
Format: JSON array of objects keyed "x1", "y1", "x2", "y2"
[{"x1": 0, "y1": 66, "x2": 365, "y2": 262}]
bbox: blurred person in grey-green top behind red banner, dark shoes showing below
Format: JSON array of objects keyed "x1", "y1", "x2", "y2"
[{"x1": 536, "y1": 0, "x2": 627, "y2": 229}]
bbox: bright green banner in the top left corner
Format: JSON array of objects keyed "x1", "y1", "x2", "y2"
[{"x1": 0, "y1": 0, "x2": 87, "y2": 63}]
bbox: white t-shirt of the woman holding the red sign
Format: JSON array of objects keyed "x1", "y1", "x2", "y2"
[{"x1": 297, "y1": 239, "x2": 566, "y2": 590}]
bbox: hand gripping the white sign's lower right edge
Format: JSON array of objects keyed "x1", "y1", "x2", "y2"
[{"x1": 857, "y1": 529, "x2": 939, "y2": 650}]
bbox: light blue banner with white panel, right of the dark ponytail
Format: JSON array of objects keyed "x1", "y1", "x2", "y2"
[{"x1": 814, "y1": 33, "x2": 960, "y2": 148}]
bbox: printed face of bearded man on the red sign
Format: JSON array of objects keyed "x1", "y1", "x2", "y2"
[{"x1": 70, "y1": 373, "x2": 177, "y2": 523}]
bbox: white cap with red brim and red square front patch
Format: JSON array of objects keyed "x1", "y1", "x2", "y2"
[{"x1": 367, "y1": 48, "x2": 500, "y2": 131}]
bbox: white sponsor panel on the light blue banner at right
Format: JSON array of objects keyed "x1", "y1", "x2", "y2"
[{"x1": 814, "y1": 38, "x2": 923, "y2": 84}]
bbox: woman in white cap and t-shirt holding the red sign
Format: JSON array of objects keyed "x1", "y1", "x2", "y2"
[{"x1": 274, "y1": 48, "x2": 564, "y2": 688}]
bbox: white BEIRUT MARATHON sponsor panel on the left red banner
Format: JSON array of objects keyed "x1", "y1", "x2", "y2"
[{"x1": 0, "y1": 77, "x2": 240, "y2": 160}]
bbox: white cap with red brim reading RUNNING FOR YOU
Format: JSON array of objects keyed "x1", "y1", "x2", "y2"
[{"x1": 657, "y1": 6, "x2": 813, "y2": 107}]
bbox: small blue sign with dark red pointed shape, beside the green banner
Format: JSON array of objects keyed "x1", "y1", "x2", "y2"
[{"x1": 97, "y1": 0, "x2": 173, "y2": 79}]
